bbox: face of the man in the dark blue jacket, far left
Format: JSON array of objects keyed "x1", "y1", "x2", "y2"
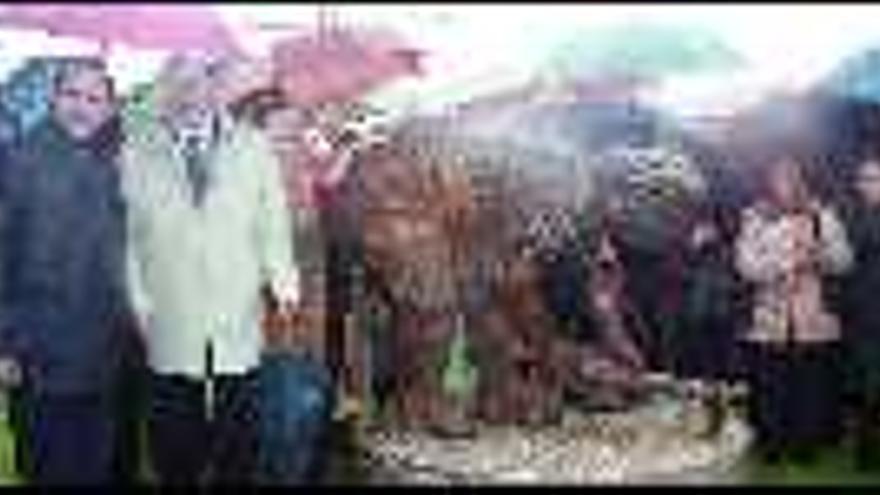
[{"x1": 52, "y1": 59, "x2": 115, "y2": 141}]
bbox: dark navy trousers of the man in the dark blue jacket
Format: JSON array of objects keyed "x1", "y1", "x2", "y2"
[{"x1": 27, "y1": 395, "x2": 114, "y2": 485}]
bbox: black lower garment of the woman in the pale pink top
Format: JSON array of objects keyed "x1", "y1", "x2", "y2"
[{"x1": 746, "y1": 343, "x2": 843, "y2": 460}]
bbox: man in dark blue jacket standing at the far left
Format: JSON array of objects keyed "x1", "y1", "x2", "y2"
[{"x1": 0, "y1": 60, "x2": 127, "y2": 483}]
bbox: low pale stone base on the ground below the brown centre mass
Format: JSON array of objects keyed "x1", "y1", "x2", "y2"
[{"x1": 365, "y1": 398, "x2": 751, "y2": 485}]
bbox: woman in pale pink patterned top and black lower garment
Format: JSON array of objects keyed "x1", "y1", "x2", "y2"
[{"x1": 735, "y1": 150, "x2": 852, "y2": 460}]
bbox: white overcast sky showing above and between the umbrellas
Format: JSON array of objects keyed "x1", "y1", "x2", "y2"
[{"x1": 0, "y1": 4, "x2": 880, "y2": 113}]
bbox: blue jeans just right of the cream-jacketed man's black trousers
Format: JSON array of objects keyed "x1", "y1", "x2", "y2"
[{"x1": 260, "y1": 353, "x2": 334, "y2": 484}]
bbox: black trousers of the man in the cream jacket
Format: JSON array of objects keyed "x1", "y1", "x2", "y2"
[{"x1": 149, "y1": 372, "x2": 259, "y2": 485}]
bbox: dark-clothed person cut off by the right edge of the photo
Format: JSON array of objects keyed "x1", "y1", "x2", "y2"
[{"x1": 842, "y1": 158, "x2": 880, "y2": 467}]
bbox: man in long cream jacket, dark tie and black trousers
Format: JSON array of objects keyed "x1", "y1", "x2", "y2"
[{"x1": 122, "y1": 55, "x2": 298, "y2": 484}]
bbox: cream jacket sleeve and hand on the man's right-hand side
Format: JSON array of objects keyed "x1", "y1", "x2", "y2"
[{"x1": 251, "y1": 132, "x2": 301, "y2": 304}]
